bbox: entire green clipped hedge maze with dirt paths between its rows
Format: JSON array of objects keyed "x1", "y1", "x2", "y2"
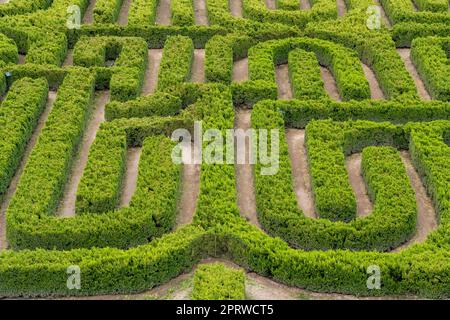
[{"x1": 0, "y1": 0, "x2": 450, "y2": 299}]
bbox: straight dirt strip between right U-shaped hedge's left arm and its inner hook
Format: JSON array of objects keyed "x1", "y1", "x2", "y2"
[{"x1": 286, "y1": 129, "x2": 317, "y2": 218}]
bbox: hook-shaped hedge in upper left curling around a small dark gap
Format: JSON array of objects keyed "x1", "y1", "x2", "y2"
[{"x1": 73, "y1": 37, "x2": 148, "y2": 101}]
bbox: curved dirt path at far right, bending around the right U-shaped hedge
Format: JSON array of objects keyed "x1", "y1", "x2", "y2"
[{"x1": 393, "y1": 151, "x2": 438, "y2": 252}]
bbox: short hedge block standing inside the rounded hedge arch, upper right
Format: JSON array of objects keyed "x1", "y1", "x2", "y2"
[{"x1": 288, "y1": 49, "x2": 328, "y2": 100}]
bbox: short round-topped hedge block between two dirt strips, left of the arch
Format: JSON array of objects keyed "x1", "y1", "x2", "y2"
[{"x1": 158, "y1": 36, "x2": 194, "y2": 90}]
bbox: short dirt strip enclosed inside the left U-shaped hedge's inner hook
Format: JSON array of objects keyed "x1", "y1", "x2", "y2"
[{"x1": 119, "y1": 148, "x2": 142, "y2": 208}]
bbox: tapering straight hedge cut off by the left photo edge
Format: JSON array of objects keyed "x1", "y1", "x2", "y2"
[{"x1": 0, "y1": 78, "x2": 48, "y2": 198}]
